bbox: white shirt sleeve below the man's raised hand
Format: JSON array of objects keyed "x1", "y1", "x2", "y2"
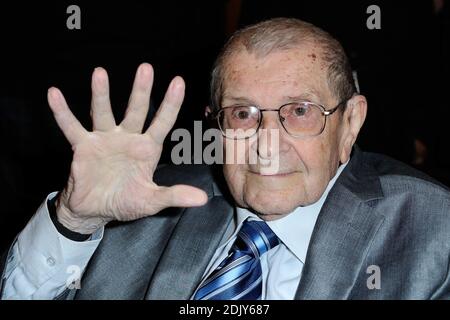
[{"x1": 1, "y1": 192, "x2": 103, "y2": 300}]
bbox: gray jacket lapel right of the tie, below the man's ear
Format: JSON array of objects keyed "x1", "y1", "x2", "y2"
[{"x1": 295, "y1": 149, "x2": 383, "y2": 299}]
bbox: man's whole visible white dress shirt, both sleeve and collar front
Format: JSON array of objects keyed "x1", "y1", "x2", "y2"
[{"x1": 1, "y1": 164, "x2": 346, "y2": 300}]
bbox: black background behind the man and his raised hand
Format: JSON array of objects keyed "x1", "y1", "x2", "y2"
[{"x1": 0, "y1": 0, "x2": 450, "y2": 246}]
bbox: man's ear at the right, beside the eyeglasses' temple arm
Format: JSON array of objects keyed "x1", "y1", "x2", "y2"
[{"x1": 339, "y1": 95, "x2": 367, "y2": 163}]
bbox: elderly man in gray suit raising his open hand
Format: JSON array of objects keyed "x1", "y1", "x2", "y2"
[{"x1": 2, "y1": 18, "x2": 450, "y2": 300}]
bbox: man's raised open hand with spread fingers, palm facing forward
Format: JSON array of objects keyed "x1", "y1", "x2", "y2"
[{"x1": 48, "y1": 63, "x2": 207, "y2": 234}]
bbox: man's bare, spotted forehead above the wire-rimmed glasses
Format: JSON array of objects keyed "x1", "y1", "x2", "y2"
[{"x1": 223, "y1": 45, "x2": 329, "y2": 103}]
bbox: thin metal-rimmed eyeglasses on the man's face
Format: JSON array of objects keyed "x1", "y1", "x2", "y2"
[{"x1": 213, "y1": 99, "x2": 348, "y2": 140}]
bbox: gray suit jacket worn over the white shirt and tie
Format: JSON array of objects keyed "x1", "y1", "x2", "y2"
[{"x1": 0, "y1": 148, "x2": 450, "y2": 299}]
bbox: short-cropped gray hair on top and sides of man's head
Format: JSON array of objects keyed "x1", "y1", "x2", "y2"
[{"x1": 210, "y1": 18, "x2": 356, "y2": 111}]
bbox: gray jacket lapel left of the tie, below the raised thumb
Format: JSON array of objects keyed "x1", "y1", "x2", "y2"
[{"x1": 146, "y1": 192, "x2": 233, "y2": 300}]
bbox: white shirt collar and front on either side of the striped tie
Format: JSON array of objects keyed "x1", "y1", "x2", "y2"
[{"x1": 194, "y1": 162, "x2": 348, "y2": 300}]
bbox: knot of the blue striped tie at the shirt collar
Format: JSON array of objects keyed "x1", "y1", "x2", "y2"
[{"x1": 235, "y1": 220, "x2": 280, "y2": 257}]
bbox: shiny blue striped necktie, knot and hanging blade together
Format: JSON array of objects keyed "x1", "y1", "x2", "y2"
[{"x1": 193, "y1": 221, "x2": 280, "y2": 300}]
